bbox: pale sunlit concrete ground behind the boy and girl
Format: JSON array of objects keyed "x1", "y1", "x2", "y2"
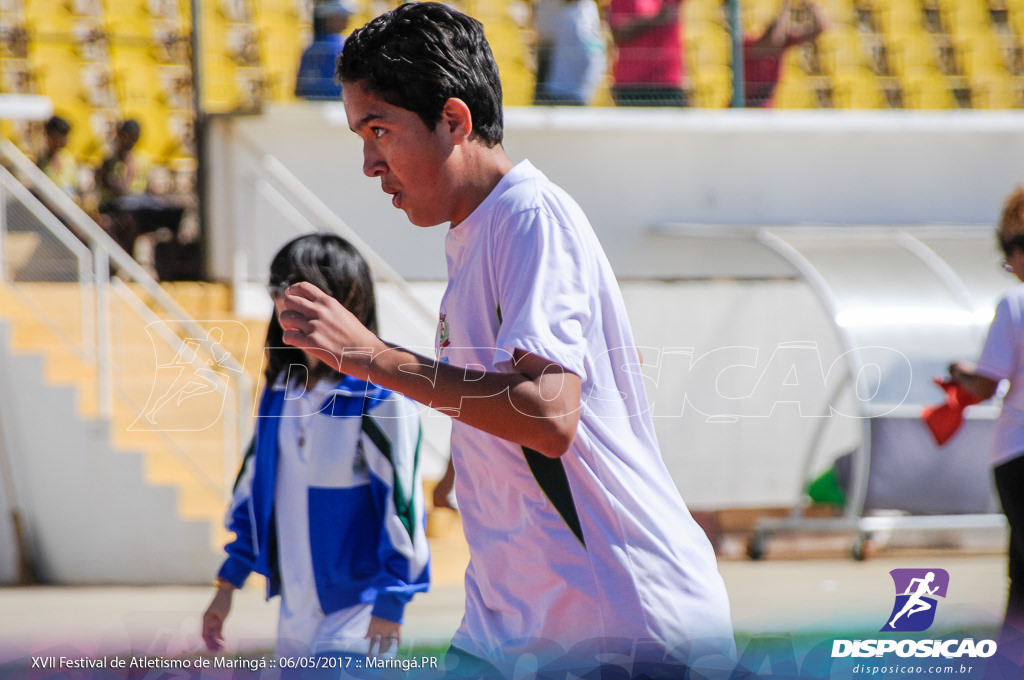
[{"x1": 0, "y1": 551, "x2": 1006, "y2": 664}]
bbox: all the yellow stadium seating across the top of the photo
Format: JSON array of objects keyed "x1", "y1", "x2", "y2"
[{"x1": 0, "y1": 0, "x2": 1024, "y2": 168}]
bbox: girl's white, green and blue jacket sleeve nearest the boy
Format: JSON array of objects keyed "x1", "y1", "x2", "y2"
[{"x1": 362, "y1": 394, "x2": 430, "y2": 624}]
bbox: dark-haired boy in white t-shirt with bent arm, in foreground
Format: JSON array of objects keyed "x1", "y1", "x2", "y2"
[{"x1": 281, "y1": 3, "x2": 732, "y2": 677}]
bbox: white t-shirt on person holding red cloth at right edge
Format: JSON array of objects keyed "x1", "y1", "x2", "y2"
[{"x1": 977, "y1": 285, "x2": 1024, "y2": 465}]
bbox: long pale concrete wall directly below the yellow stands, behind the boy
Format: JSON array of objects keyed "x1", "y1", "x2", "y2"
[{"x1": 203, "y1": 102, "x2": 1024, "y2": 280}]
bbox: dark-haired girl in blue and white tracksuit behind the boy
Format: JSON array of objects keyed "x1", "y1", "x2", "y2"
[{"x1": 203, "y1": 233, "x2": 429, "y2": 656}]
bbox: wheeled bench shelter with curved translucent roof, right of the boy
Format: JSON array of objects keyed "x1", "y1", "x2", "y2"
[{"x1": 653, "y1": 224, "x2": 1012, "y2": 559}]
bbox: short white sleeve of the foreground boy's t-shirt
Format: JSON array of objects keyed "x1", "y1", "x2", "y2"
[{"x1": 493, "y1": 201, "x2": 594, "y2": 378}]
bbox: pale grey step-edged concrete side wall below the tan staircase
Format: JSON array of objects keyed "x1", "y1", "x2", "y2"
[{"x1": 0, "y1": 324, "x2": 219, "y2": 585}]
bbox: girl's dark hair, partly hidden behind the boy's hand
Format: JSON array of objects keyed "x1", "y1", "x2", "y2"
[{"x1": 263, "y1": 232, "x2": 377, "y2": 385}]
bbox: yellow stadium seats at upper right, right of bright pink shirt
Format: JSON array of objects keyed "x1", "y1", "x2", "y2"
[{"x1": 684, "y1": 0, "x2": 1024, "y2": 109}]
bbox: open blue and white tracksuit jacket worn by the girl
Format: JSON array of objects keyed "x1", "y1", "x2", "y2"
[{"x1": 218, "y1": 376, "x2": 430, "y2": 623}]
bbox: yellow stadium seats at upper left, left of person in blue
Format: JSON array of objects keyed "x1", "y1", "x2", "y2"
[{"x1": 0, "y1": 0, "x2": 310, "y2": 164}]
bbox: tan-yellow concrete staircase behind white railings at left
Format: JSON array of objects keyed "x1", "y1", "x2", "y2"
[{"x1": 0, "y1": 283, "x2": 265, "y2": 549}]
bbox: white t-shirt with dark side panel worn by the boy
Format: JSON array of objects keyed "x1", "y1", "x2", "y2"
[{"x1": 437, "y1": 161, "x2": 732, "y2": 667}]
